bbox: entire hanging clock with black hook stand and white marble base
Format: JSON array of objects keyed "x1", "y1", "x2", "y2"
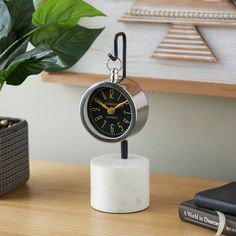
[{"x1": 80, "y1": 32, "x2": 150, "y2": 214}]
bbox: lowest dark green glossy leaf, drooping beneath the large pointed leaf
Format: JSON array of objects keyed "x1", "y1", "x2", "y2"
[{"x1": 3, "y1": 45, "x2": 68, "y2": 85}]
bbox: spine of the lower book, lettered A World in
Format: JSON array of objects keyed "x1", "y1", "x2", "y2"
[{"x1": 179, "y1": 205, "x2": 236, "y2": 236}]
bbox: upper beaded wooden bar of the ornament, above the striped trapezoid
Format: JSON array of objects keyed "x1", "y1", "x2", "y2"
[{"x1": 121, "y1": 0, "x2": 236, "y2": 26}]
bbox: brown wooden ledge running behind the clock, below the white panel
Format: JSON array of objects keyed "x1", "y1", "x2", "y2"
[{"x1": 42, "y1": 72, "x2": 236, "y2": 98}]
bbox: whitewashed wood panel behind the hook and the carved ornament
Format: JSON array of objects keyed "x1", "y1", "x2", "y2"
[{"x1": 74, "y1": 0, "x2": 236, "y2": 84}]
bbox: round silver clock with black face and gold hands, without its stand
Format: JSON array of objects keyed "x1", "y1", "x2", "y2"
[{"x1": 80, "y1": 78, "x2": 148, "y2": 142}]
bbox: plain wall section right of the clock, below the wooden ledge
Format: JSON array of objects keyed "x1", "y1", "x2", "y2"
[{"x1": 130, "y1": 93, "x2": 236, "y2": 179}]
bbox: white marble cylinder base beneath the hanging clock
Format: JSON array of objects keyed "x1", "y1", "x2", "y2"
[{"x1": 90, "y1": 154, "x2": 150, "y2": 213}]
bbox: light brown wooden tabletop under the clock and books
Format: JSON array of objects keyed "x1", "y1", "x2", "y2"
[{"x1": 0, "y1": 161, "x2": 224, "y2": 236}]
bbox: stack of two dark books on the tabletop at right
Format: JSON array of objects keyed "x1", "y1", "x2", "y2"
[{"x1": 179, "y1": 182, "x2": 236, "y2": 235}]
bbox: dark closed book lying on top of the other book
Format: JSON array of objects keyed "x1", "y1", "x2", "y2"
[{"x1": 194, "y1": 182, "x2": 236, "y2": 216}]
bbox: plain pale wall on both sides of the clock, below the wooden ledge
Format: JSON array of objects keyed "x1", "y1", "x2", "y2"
[{"x1": 0, "y1": 76, "x2": 236, "y2": 180}]
